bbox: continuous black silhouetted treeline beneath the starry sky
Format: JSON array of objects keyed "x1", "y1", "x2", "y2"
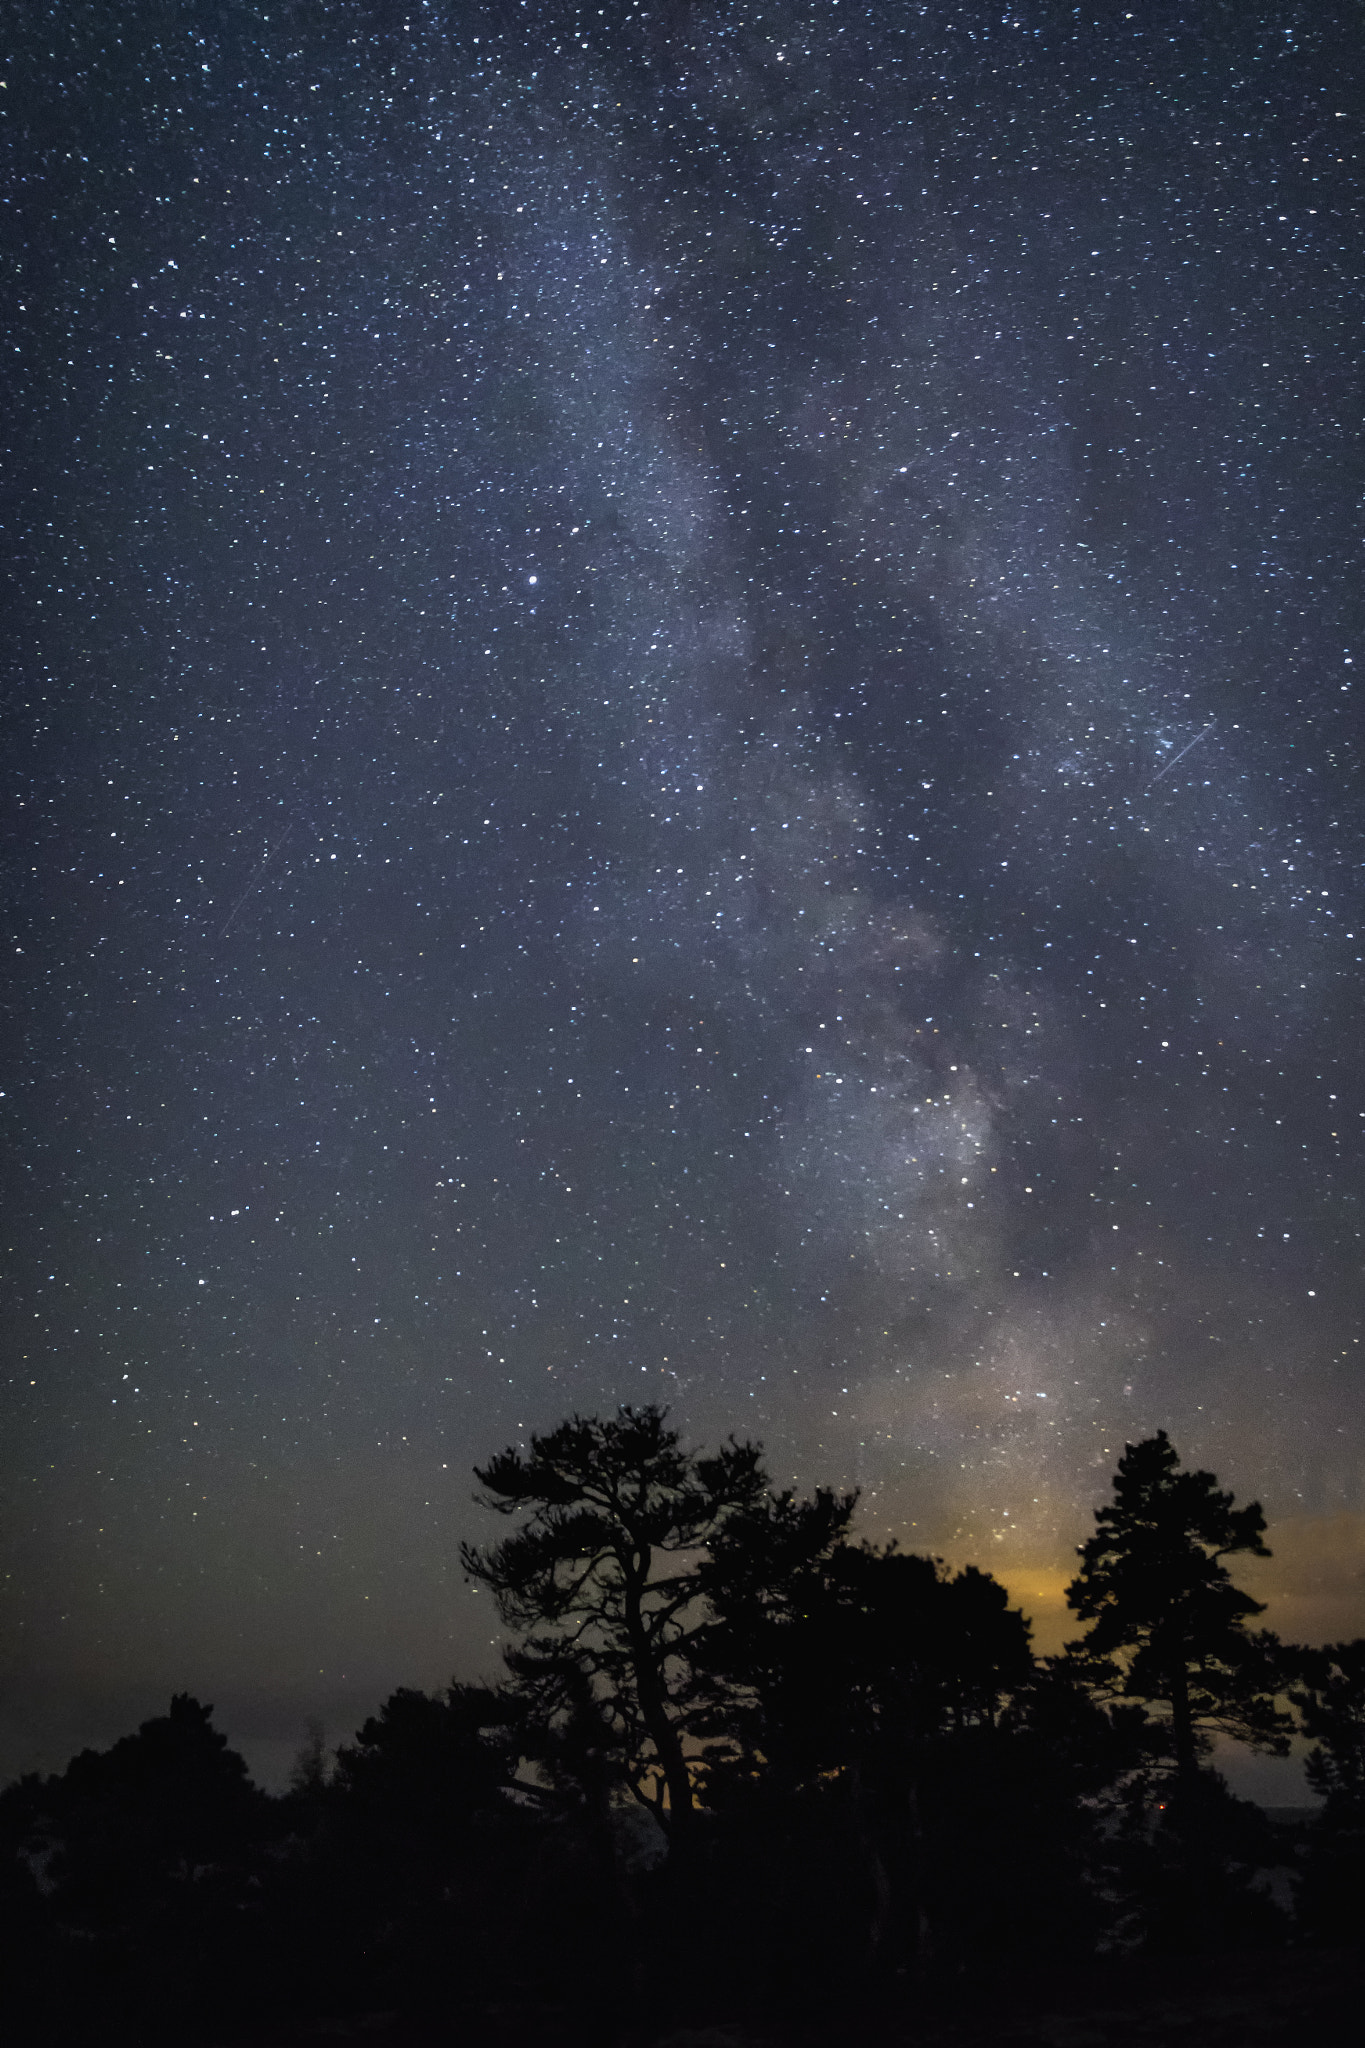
[{"x1": 0, "y1": 1407, "x2": 1365, "y2": 2042}]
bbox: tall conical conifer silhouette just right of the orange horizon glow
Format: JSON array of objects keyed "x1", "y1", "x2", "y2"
[{"x1": 1066, "y1": 1430, "x2": 1291, "y2": 1794}]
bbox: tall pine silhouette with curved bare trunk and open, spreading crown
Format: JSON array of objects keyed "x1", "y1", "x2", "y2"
[{"x1": 460, "y1": 1405, "x2": 765, "y2": 1835}]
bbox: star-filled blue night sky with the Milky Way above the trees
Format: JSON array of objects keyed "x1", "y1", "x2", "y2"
[{"x1": 0, "y1": 0, "x2": 1365, "y2": 1780}]
